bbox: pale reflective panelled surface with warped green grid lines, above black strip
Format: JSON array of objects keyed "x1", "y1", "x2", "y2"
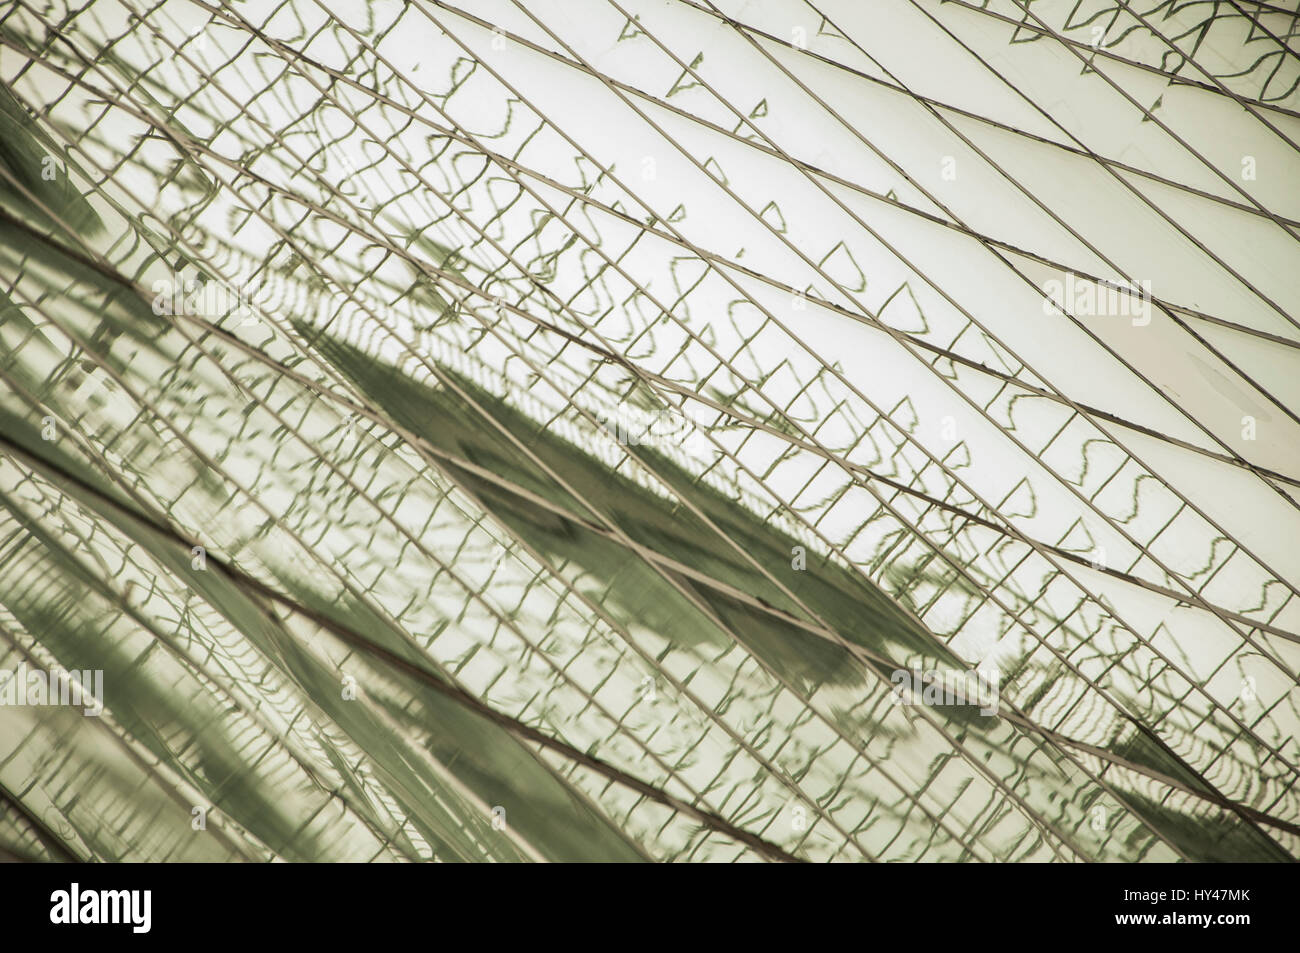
[{"x1": 0, "y1": 0, "x2": 1300, "y2": 861}]
